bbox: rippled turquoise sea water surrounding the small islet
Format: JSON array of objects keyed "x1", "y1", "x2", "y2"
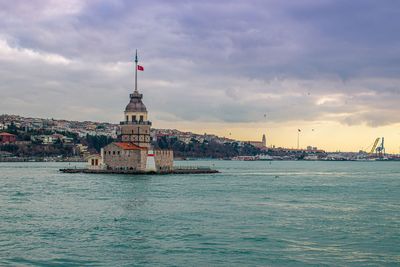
[{"x1": 0, "y1": 161, "x2": 400, "y2": 266}]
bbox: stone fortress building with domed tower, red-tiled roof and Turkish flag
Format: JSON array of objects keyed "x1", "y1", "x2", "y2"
[{"x1": 101, "y1": 54, "x2": 173, "y2": 171}]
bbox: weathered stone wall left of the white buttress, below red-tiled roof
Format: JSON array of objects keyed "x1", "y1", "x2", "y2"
[{"x1": 103, "y1": 143, "x2": 147, "y2": 171}]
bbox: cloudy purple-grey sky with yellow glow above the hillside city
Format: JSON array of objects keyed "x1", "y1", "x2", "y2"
[{"x1": 0, "y1": 0, "x2": 400, "y2": 153}]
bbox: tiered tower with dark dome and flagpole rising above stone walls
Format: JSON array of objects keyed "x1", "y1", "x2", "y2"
[{"x1": 120, "y1": 50, "x2": 151, "y2": 148}]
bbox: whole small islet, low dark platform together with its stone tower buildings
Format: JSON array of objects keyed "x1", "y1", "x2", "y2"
[{"x1": 60, "y1": 51, "x2": 218, "y2": 174}]
